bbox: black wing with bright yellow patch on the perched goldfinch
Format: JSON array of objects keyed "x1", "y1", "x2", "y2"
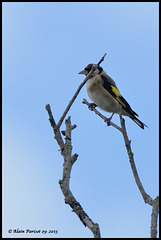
[{"x1": 100, "y1": 74, "x2": 138, "y2": 116}]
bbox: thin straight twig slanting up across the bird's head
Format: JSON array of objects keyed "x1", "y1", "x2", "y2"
[{"x1": 57, "y1": 53, "x2": 106, "y2": 128}]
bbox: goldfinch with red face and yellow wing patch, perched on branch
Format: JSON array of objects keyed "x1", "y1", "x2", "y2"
[{"x1": 79, "y1": 63, "x2": 147, "y2": 129}]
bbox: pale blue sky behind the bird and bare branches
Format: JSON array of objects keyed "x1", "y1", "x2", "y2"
[{"x1": 2, "y1": 2, "x2": 159, "y2": 238}]
